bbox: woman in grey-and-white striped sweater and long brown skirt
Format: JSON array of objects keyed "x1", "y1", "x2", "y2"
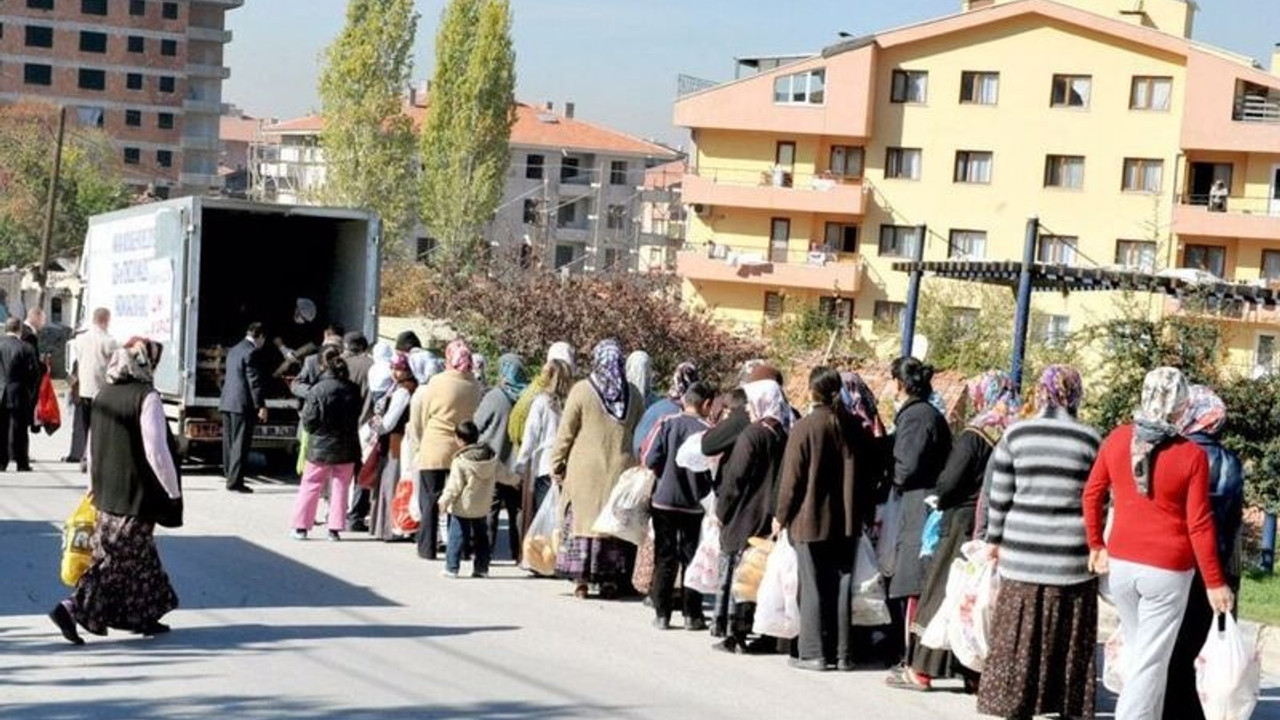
[{"x1": 978, "y1": 365, "x2": 1101, "y2": 717}]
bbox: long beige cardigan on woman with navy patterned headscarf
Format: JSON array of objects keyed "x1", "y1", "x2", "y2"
[{"x1": 552, "y1": 380, "x2": 644, "y2": 537}]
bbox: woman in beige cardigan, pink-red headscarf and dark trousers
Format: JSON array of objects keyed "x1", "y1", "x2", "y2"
[{"x1": 408, "y1": 340, "x2": 480, "y2": 560}]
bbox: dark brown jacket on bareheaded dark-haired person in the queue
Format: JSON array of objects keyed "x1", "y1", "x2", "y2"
[{"x1": 777, "y1": 406, "x2": 874, "y2": 542}]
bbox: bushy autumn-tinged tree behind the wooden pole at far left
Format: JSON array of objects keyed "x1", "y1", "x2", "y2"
[{"x1": 0, "y1": 104, "x2": 129, "y2": 266}]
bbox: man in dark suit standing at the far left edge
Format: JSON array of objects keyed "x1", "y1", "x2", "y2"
[{"x1": 0, "y1": 318, "x2": 41, "y2": 473}]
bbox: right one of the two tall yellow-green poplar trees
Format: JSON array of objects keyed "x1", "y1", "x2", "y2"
[{"x1": 421, "y1": 0, "x2": 516, "y2": 268}]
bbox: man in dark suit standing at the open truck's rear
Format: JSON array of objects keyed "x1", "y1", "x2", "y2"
[{"x1": 219, "y1": 323, "x2": 266, "y2": 493}]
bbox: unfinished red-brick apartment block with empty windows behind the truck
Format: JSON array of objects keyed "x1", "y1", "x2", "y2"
[{"x1": 0, "y1": 0, "x2": 244, "y2": 196}]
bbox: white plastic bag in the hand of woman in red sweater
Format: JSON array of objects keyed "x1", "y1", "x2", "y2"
[{"x1": 1196, "y1": 615, "x2": 1262, "y2": 720}]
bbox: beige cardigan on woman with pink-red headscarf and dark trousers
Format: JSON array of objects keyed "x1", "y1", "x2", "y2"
[{"x1": 408, "y1": 370, "x2": 480, "y2": 470}]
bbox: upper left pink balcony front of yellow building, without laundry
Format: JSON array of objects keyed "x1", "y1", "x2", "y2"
[{"x1": 682, "y1": 167, "x2": 867, "y2": 215}]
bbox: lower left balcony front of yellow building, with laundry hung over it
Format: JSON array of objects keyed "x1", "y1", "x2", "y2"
[{"x1": 676, "y1": 246, "x2": 863, "y2": 295}]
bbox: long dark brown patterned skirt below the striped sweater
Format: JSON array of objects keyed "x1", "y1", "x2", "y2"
[{"x1": 978, "y1": 579, "x2": 1098, "y2": 717}]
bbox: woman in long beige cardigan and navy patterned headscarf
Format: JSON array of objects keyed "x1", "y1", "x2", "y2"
[{"x1": 552, "y1": 340, "x2": 641, "y2": 598}]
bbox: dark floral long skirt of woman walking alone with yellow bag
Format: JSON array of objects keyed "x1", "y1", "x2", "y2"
[{"x1": 72, "y1": 511, "x2": 178, "y2": 635}]
